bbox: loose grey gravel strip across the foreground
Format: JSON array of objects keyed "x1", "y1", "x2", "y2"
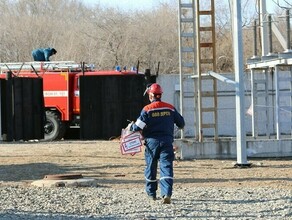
[{"x1": 0, "y1": 186, "x2": 292, "y2": 220}]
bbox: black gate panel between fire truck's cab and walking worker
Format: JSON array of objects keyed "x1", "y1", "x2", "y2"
[{"x1": 80, "y1": 75, "x2": 147, "y2": 140}]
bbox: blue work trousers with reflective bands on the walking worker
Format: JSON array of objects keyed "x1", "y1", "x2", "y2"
[{"x1": 144, "y1": 138, "x2": 174, "y2": 197}]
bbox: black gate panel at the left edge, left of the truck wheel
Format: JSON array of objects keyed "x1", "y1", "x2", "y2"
[{"x1": 0, "y1": 78, "x2": 45, "y2": 141}]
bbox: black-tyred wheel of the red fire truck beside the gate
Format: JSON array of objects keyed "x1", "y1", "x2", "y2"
[{"x1": 45, "y1": 111, "x2": 66, "y2": 141}]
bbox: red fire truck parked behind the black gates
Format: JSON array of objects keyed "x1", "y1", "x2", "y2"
[{"x1": 0, "y1": 61, "x2": 146, "y2": 141}]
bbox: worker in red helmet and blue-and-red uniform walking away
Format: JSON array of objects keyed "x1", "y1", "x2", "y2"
[{"x1": 130, "y1": 83, "x2": 185, "y2": 204}]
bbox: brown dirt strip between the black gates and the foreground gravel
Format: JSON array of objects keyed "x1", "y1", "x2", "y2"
[{"x1": 0, "y1": 140, "x2": 292, "y2": 189}]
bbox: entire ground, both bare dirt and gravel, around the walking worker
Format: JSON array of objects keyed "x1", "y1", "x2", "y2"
[{"x1": 0, "y1": 141, "x2": 292, "y2": 220}]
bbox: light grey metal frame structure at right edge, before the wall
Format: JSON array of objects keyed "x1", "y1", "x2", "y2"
[{"x1": 247, "y1": 57, "x2": 292, "y2": 140}]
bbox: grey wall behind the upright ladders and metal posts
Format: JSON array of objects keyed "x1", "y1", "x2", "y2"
[{"x1": 157, "y1": 71, "x2": 291, "y2": 137}]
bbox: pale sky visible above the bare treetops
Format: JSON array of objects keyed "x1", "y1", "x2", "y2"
[{"x1": 82, "y1": 0, "x2": 289, "y2": 13}]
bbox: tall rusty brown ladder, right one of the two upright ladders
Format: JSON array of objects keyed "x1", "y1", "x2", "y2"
[{"x1": 195, "y1": 0, "x2": 218, "y2": 142}]
